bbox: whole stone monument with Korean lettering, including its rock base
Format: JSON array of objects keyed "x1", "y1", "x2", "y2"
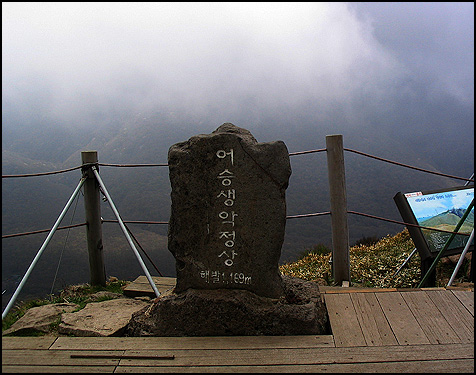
[{"x1": 127, "y1": 123, "x2": 327, "y2": 336}]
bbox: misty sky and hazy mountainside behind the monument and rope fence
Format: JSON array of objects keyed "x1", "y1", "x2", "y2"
[{"x1": 2, "y1": 2, "x2": 474, "y2": 303}]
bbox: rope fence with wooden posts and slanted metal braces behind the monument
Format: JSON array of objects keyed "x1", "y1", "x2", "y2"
[{"x1": 2, "y1": 140, "x2": 474, "y2": 306}]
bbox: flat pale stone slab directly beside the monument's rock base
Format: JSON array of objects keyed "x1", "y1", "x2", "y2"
[{"x1": 58, "y1": 298, "x2": 150, "y2": 336}]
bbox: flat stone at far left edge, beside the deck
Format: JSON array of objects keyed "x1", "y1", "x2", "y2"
[{"x1": 3, "y1": 303, "x2": 79, "y2": 335}]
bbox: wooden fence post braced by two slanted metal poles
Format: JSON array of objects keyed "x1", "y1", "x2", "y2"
[{"x1": 81, "y1": 151, "x2": 106, "y2": 286}]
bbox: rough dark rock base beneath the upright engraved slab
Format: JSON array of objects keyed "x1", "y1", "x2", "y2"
[{"x1": 125, "y1": 276, "x2": 329, "y2": 336}]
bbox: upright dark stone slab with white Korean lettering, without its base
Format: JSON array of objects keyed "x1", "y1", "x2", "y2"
[{"x1": 168, "y1": 123, "x2": 291, "y2": 298}]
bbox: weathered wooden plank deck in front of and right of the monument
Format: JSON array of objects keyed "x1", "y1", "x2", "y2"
[{"x1": 2, "y1": 287, "x2": 474, "y2": 373}]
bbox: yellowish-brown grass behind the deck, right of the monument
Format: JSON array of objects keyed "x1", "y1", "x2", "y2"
[{"x1": 280, "y1": 229, "x2": 470, "y2": 288}]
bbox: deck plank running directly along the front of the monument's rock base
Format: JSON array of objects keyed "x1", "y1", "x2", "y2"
[{"x1": 51, "y1": 335, "x2": 334, "y2": 350}]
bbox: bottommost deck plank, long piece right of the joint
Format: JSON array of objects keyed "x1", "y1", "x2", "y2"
[{"x1": 115, "y1": 359, "x2": 474, "y2": 373}]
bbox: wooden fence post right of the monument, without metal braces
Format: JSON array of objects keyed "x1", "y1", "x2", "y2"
[{"x1": 326, "y1": 135, "x2": 350, "y2": 285}]
